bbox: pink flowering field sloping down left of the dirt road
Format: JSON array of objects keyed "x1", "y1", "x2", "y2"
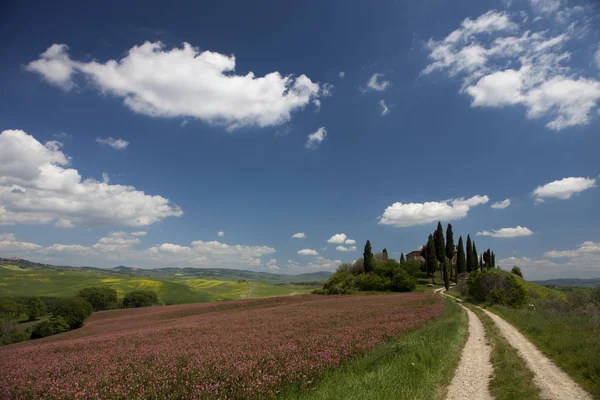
[{"x1": 0, "y1": 293, "x2": 444, "y2": 399}]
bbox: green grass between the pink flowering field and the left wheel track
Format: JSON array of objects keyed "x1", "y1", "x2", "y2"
[{"x1": 278, "y1": 300, "x2": 468, "y2": 400}]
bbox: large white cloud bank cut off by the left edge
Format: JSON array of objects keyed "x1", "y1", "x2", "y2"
[{"x1": 0, "y1": 130, "x2": 183, "y2": 227}]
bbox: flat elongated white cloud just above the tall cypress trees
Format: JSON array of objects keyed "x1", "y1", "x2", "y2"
[{"x1": 379, "y1": 195, "x2": 489, "y2": 227}]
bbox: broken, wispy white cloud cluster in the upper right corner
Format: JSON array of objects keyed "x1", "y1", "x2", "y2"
[{"x1": 423, "y1": 7, "x2": 600, "y2": 131}]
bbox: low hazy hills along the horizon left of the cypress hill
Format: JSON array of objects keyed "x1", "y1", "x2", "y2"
[{"x1": 0, "y1": 258, "x2": 332, "y2": 284}]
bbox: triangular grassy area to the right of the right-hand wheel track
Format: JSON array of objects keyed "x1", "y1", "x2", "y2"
[{"x1": 489, "y1": 306, "x2": 600, "y2": 399}]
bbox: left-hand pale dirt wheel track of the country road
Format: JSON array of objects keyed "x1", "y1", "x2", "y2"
[{"x1": 446, "y1": 305, "x2": 493, "y2": 400}]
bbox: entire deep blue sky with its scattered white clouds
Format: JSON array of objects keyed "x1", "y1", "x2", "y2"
[{"x1": 0, "y1": 0, "x2": 600, "y2": 279}]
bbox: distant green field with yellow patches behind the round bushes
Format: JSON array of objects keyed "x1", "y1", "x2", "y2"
[{"x1": 0, "y1": 265, "x2": 314, "y2": 304}]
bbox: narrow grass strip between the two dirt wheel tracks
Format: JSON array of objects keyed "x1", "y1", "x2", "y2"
[{"x1": 465, "y1": 304, "x2": 540, "y2": 400}]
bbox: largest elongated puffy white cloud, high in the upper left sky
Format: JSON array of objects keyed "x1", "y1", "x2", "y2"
[{"x1": 26, "y1": 42, "x2": 320, "y2": 129}]
